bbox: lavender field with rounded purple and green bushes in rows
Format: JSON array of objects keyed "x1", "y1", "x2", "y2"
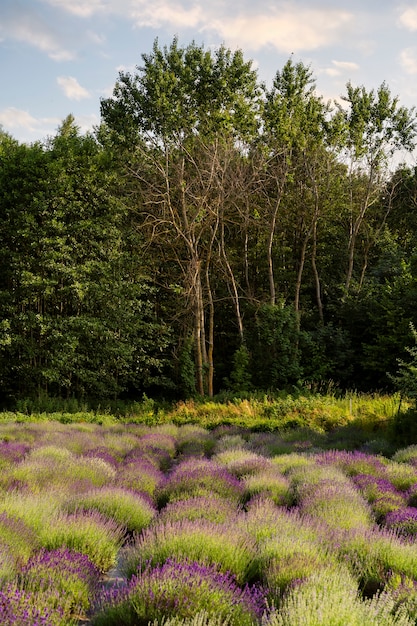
[{"x1": 0, "y1": 421, "x2": 417, "y2": 626}]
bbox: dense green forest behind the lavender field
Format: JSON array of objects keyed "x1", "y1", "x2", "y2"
[{"x1": 0, "y1": 39, "x2": 417, "y2": 404}]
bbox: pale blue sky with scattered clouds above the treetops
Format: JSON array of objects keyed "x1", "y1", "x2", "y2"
[{"x1": 0, "y1": 0, "x2": 417, "y2": 143}]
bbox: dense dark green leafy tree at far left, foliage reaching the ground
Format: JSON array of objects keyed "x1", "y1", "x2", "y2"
[{"x1": 0, "y1": 117, "x2": 169, "y2": 398}]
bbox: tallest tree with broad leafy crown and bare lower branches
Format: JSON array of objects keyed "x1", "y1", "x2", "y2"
[{"x1": 101, "y1": 39, "x2": 259, "y2": 395}]
